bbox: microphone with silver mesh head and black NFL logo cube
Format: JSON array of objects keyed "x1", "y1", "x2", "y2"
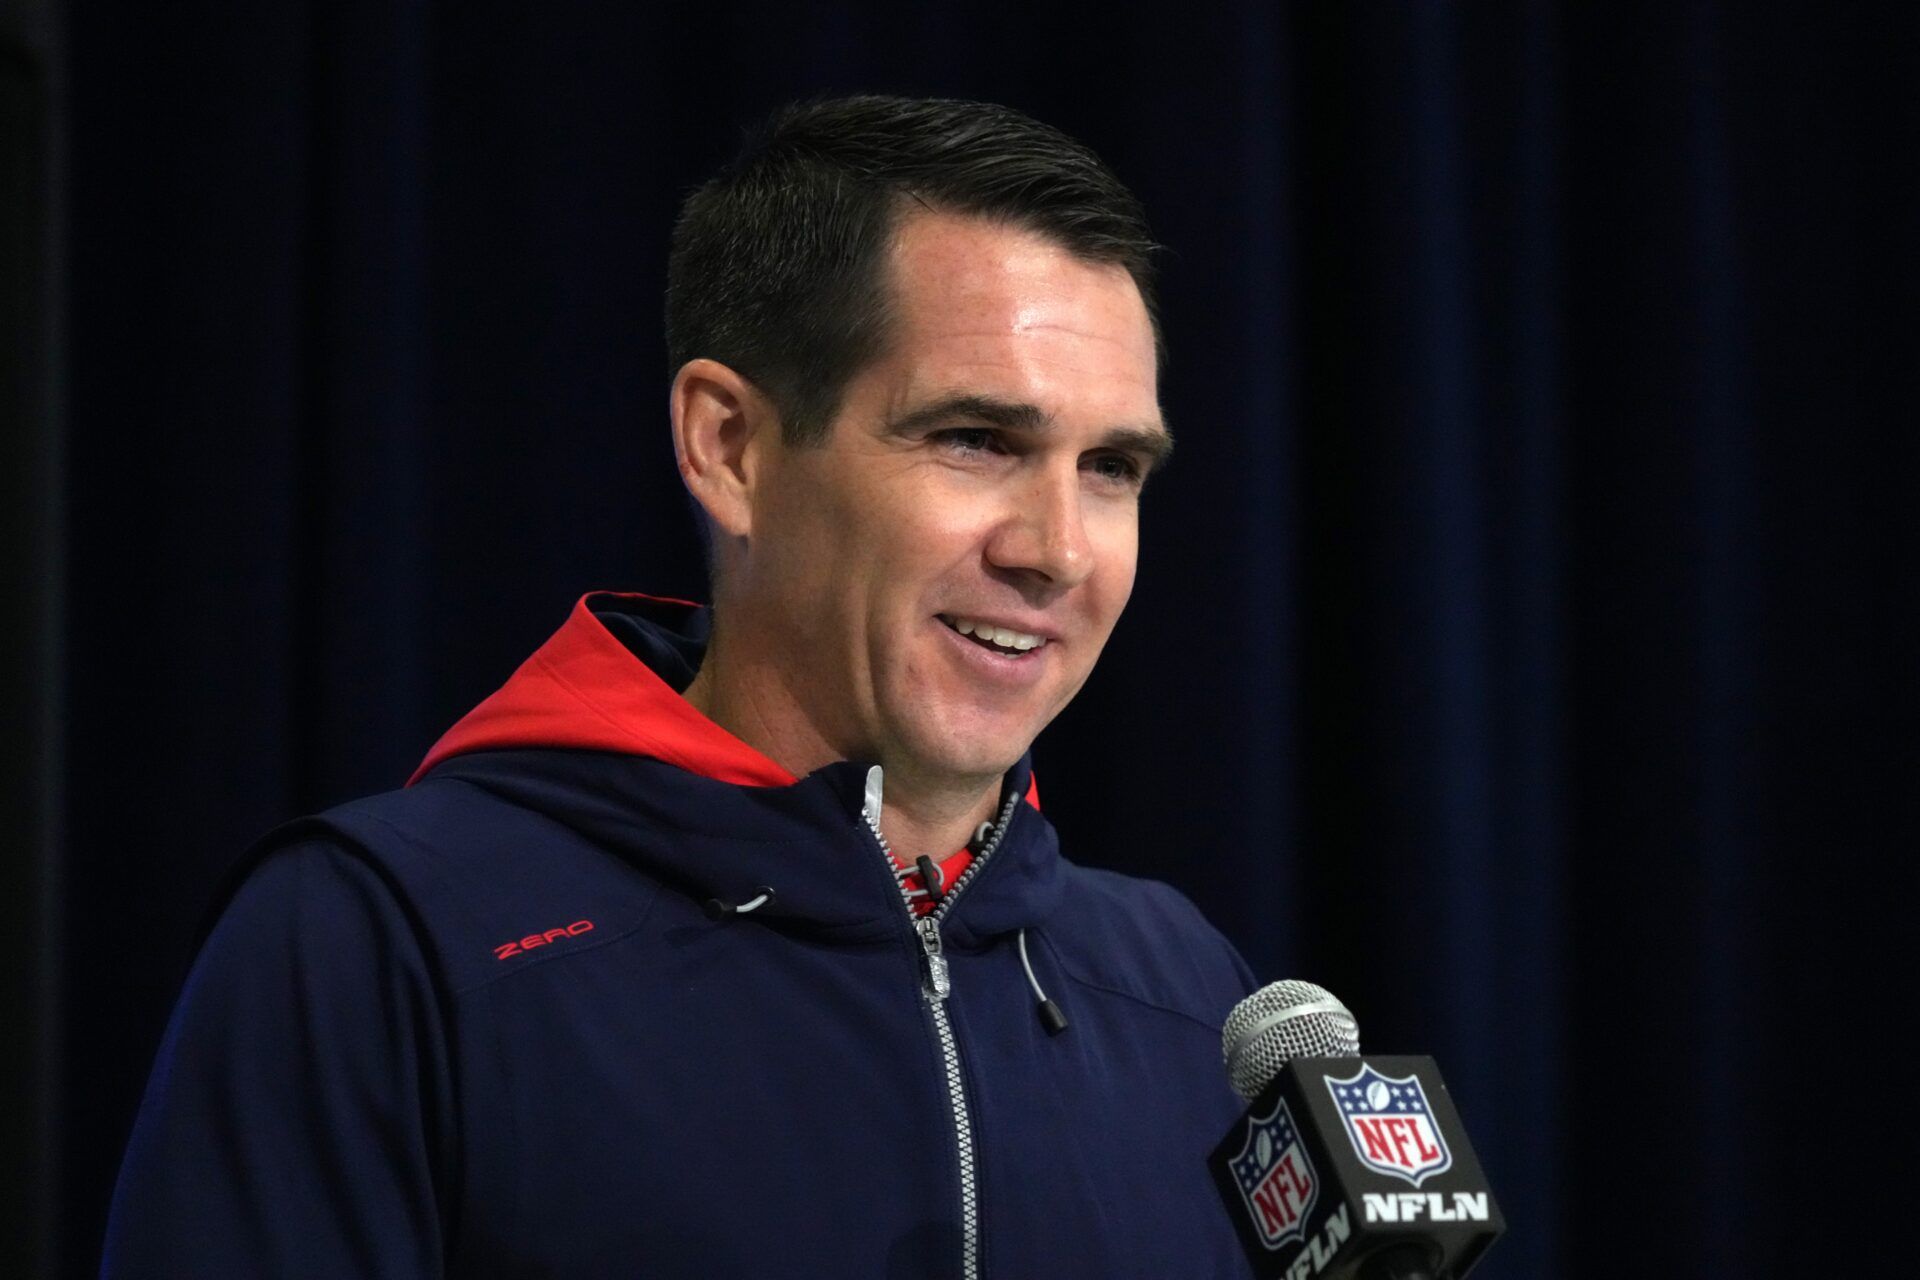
[{"x1": 1208, "y1": 981, "x2": 1507, "y2": 1280}]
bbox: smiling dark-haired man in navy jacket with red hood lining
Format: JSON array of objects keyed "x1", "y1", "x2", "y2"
[{"x1": 106, "y1": 98, "x2": 1252, "y2": 1278}]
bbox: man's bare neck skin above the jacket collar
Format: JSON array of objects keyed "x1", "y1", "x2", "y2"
[{"x1": 682, "y1": 633, "x2": 1002, "y2": 864}]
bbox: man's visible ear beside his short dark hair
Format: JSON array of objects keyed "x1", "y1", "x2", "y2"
[{"x1": 670, "y1": 359, "x2": 780, "y2": 537}]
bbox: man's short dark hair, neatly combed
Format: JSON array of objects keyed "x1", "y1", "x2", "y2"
[{"x1": 666, "y1": 96, "x2": 1160, "y2": 443}]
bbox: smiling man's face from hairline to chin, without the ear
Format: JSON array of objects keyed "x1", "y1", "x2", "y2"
[{"x1": 722, "y1": 213, "x2": 1167, "y2": 783}]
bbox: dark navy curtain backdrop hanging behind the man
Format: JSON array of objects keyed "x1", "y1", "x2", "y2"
[{"x1": 22, "y1": 0, "x2": 1920, "y2": 1280}]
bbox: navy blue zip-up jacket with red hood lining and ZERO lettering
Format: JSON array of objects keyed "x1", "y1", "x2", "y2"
[{"x1": 104, "y1": 595, "x2": 1252, "y2": 1280}]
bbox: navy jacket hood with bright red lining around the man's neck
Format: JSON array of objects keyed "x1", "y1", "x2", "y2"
[{"x1": 409, "y1": 591, "x2": 1066, "y2": 946}]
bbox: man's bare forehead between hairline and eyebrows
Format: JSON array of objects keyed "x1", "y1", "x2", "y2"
[{"x1": 881, "y1": 211, "x2": 1158, "y2": 422}]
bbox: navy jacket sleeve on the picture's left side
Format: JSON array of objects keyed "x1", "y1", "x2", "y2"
[{"x1": 102, "y1": 841, "x2": 451, "y2": 1280}]
